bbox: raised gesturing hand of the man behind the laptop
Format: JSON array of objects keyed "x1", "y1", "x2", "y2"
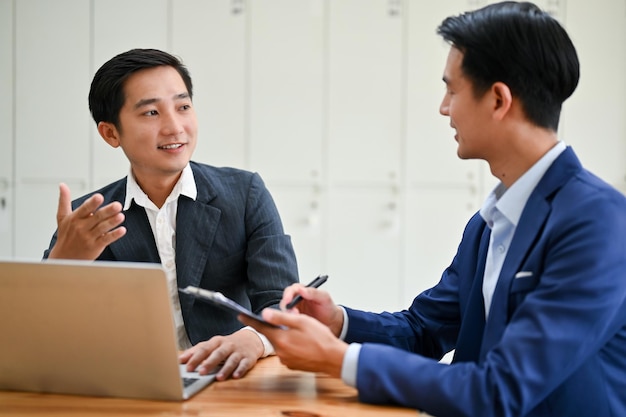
[{"x1": 49, "y1": 184, "x2": 126, "y2": 260}]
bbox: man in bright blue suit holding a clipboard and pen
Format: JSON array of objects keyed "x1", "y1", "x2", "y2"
[{"x1": 242, "y1": 2, "x2": 626, "y2": 417}]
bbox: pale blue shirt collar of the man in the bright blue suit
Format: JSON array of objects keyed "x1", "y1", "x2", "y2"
[{"x1": 480, "y1": 141, "x2": 566, "y2": 226}]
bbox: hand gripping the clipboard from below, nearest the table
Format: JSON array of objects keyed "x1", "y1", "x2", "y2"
[{"x1": 238, "y1": 308, "x2": 348, "y2": 377}]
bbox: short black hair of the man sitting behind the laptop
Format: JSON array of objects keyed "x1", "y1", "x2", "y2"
[{"x1": 89, "y1": 49, "x2": 193, "y2": 129}]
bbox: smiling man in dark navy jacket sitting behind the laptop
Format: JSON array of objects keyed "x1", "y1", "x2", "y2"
[{"x1": 44, "y1": 49, "x2": 298, "y2": 379}]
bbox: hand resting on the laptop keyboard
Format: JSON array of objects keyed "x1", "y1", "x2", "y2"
[{"x1": 179, "y1": 329, "x2": 265, "y2": 381}]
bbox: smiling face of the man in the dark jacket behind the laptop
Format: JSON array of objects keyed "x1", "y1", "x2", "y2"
[{"x1": 102, "y1": 66, "x2": 198, "y2": 185}]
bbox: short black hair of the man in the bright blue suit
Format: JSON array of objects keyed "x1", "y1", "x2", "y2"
[{"x1": 437, "y1": 1, "x2": 580, "y2": 131}]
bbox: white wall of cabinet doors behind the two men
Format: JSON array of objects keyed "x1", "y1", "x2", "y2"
[{"x1": 0, "y1": 0, "x2": 626, "y2": 310}]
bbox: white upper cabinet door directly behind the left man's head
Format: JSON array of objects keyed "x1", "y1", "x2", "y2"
[{"x1": 90, "y1": 0, "x2": 169, "y2": 188}]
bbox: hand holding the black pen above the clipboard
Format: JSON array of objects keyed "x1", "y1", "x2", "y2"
[{"x1": 280, "y1": 284, "x2": 343, "y2": 337}]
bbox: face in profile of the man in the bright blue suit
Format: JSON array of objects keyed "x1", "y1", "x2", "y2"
[{"x1": 439, "y1": 47, "x2": 491, "y2": 160}]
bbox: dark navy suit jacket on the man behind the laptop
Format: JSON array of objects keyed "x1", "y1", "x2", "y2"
[{"x1": 44, "y1": 162, "x2": 298, "y2": 344}]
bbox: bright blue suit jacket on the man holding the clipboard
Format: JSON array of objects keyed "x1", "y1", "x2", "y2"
[{"x1": 346, "y1": 148, "x2": 626, "y2": 417}]
